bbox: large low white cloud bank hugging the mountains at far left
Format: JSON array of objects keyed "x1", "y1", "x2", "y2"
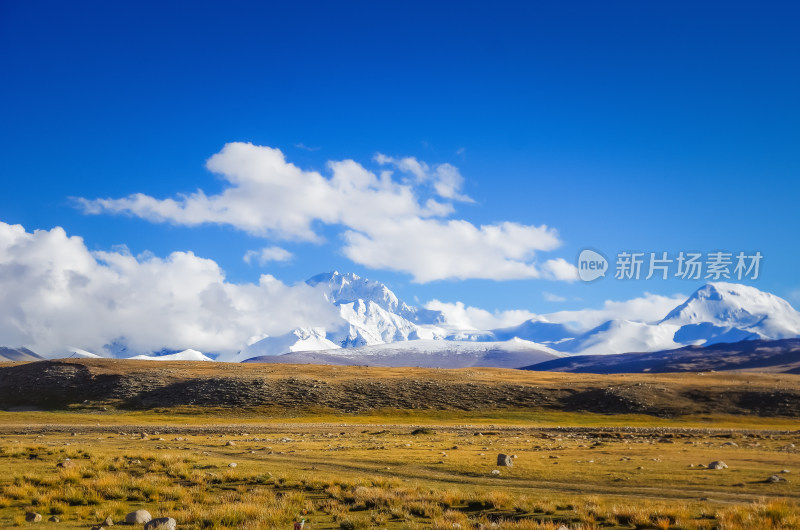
[{"x1": 0, "y1": 222, "x2": 337, "y2": 355}]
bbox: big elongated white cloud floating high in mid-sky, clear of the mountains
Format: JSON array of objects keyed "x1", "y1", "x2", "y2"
[{"x1": 77, "y1": 143, "x2": 577, "y2": 282}]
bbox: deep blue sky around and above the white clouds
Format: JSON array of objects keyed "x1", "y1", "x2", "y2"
[{"x1": 0, "y1": 1, "x2": 800, "y2": 330}]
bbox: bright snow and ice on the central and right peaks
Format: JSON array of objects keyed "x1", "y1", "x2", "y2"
[{"x1": 236, "y1": 272, "x2": 800, "y2": 360}]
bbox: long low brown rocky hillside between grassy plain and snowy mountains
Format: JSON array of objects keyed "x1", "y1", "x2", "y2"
[{"x1": 0, "y1": 359, "x2": 800, "y2": 417}]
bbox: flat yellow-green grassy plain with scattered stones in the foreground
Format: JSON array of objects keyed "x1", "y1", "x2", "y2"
[{"x1": 0, "y1": 360, "x2": 800, "y2": 530}]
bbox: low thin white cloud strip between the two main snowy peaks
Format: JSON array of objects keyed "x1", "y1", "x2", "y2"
[{"x1": 425, "y1": 292, "x2": 686, "y2": 330}]
